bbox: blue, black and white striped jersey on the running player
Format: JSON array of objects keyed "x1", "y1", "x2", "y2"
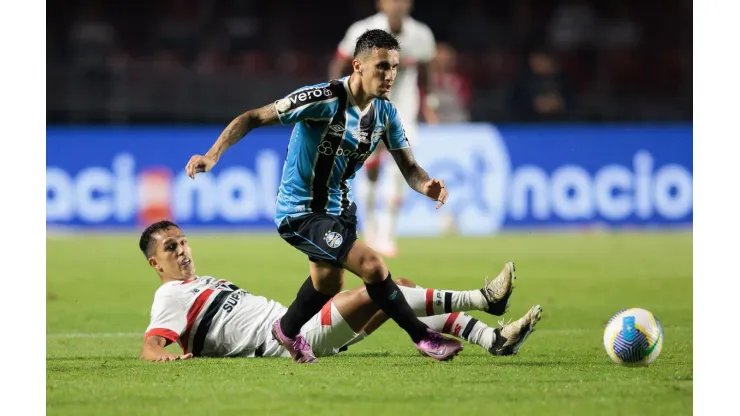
[{"x1": 275, "y1": 77, "x2": 409, "y2": 225}]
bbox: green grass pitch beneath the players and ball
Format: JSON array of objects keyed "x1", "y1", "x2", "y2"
[{"x1": 46, "y1": 230, "x2": 693, "y2": 416}]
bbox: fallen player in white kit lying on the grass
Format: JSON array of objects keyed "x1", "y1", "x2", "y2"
[{"x1": 139, "y1": 221, "x2": 541, "y2": 361}]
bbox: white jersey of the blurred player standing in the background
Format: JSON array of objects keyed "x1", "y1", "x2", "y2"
[{"x1": 337, "y1": 13, "x2": 437, "y2": 124}]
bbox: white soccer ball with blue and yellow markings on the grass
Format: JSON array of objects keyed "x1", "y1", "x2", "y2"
[{"x1": 604, "y1": 308, "x2": 663, "y2": 367}]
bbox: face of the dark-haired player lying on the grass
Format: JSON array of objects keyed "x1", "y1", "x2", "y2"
[{"x1": 149, "y1": 227, "x2": 195, "y2": 280}]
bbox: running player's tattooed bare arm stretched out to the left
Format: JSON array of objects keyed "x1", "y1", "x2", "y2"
[{"x1": 185, "y1": 104, "x2": 280, "y2": 178}]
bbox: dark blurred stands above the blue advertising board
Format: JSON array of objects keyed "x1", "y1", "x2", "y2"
[{"x1": 46, "y1": 0, "x2": 692, "y2": 124}]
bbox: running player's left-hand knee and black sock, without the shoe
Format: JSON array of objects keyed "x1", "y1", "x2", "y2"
[{"x1": 280, "y1": 262, "x2": 344, "y2": 338}]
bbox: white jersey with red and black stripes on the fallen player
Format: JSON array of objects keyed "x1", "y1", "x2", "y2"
[{"x1": 146, "y1": 276, "x2": 286, "y2": 357}]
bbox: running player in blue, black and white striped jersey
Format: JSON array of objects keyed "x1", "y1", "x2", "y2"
[{"x1": 185, "y1": 29, "x2": 462, "y2": 363}]
